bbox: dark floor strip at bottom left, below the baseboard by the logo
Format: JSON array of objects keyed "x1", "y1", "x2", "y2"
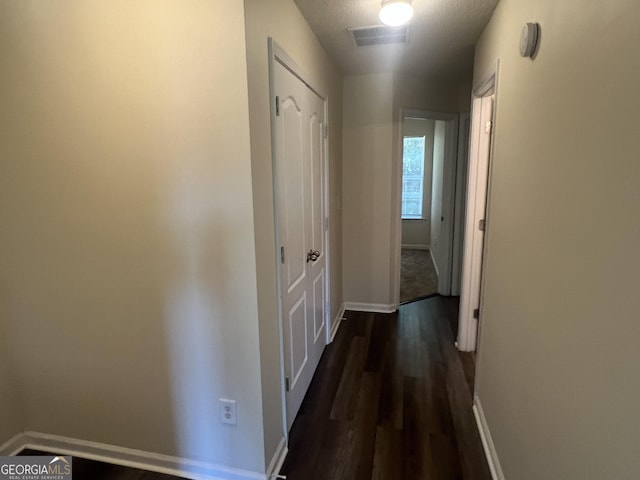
[{"x1": 19, "y1": 449, "x2": 185, "y2": 480}]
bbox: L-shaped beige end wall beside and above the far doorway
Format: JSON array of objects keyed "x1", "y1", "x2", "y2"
[{"x1": 343, "y1": 74, "x2": 463, "y2": 307}]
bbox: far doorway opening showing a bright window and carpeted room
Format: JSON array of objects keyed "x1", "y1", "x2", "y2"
[{"x1": 395, "y1": 110, "x2": 469, "y2": 305}]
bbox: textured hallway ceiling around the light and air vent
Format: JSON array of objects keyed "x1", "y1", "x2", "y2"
[{"x1": 294, "y1": 0, "x2": 498, "y2": 81}]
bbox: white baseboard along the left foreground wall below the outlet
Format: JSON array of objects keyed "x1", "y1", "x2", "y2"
[{"x1": 8, "y1": 432, "x2": 268, "y2": 480}]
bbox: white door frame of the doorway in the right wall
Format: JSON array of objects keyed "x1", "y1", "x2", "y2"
[{"x1": 456, "y1": 61, "x2": 500, "y2": 352}]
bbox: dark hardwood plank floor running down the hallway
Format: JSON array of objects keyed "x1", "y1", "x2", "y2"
[{"x1": 281, "y1": 297, "x2": 491, "y2": 480}]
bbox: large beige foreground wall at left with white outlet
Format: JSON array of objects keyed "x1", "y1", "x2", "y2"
[{"x1": 0, "y1": 0, "x2": 265, "y2": 471}]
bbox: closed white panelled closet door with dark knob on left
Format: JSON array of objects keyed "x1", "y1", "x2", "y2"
[{"x1": 273, "y1": 60, "x2": 326, "y2": 429}]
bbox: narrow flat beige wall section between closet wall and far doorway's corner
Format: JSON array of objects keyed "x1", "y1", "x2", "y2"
[{"x1": 343, "y1": 74, "x2": 393, "y2": 305}]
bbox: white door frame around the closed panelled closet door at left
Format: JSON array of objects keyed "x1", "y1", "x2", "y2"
[{"x1": 268, "y1": 37, "x2": 331, "y2": 443}]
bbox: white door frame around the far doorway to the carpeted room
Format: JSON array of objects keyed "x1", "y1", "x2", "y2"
[{"x1": 391, "y1": 108, "x2": 458, "y2": 309}]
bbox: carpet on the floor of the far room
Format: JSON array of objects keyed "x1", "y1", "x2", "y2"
[{"x1": 400, "y1": 248, "x2": 438, "y2": 303}]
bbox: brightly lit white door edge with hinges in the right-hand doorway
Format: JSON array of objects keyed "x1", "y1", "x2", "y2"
[{"x1": 458, "y1": 96, "x2": 493, "y2": 351}]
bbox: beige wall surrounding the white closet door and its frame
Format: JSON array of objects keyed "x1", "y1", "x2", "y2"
[{"x1": 245, "y1": 0, "x2": 343, "y2": 459}]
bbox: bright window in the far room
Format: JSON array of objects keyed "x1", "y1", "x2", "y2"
[{"x1": 402, "y1": 137, "x2": 424, "y2": 219}]
